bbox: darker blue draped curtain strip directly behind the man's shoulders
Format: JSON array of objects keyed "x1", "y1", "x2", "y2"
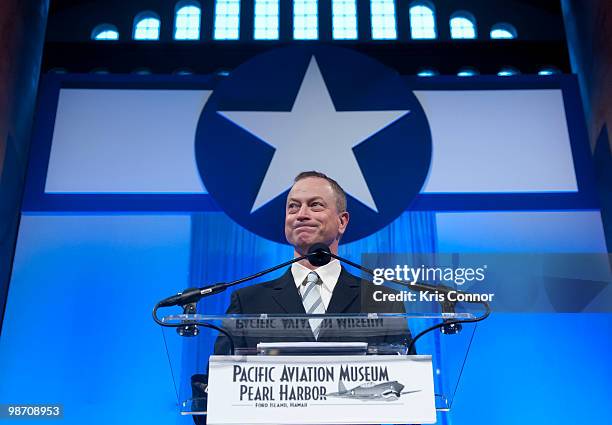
[{"x1": 190, "y1": 212, "x2": 436, "y2": 352}]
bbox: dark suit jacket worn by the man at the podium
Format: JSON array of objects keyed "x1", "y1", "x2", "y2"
[{"x1": 215, "y1": 268, "x2": 411, "y2": 354}]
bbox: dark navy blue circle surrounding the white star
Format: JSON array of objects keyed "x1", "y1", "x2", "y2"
[{"x1": 195, "y1": 46, "x2": 432, "y2": 243}]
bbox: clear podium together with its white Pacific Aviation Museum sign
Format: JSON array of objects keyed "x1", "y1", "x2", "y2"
[{"x1": 162, "y1": 313, "x2": 477, "y2": 416}]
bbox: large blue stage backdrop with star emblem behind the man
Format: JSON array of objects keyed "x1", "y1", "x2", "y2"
[{"x1": 0, "y1": 46, "x2": 612, "y2": 425}]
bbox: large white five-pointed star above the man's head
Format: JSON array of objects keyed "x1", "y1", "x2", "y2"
[{"x1": 217, "y1": 56, "x2": 410, "y2": 213}]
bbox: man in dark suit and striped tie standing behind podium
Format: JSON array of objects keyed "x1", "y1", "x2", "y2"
[{"x1": 215, "y1": 171, "x2": 410, "y2": 352}]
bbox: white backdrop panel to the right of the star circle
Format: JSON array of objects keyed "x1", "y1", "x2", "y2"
[{"x1": 415, "y1": 90, "x2": 578, "y2": 193}]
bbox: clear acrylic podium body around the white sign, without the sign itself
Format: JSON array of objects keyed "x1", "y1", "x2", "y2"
[{"x1": 162, "y1": 313, "x2": 477, "y2": 415}]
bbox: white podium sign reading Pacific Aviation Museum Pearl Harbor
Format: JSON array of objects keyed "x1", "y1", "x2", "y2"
[{"x1": 207, "y1": 355, "x2": 436, "y2": 425}]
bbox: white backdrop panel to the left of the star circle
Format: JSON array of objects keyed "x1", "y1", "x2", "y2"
[{"x1": 45, "y1": 89, "x2": 211, "y2": 193}]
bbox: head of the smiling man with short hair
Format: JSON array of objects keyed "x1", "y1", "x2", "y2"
[{"x1": 285, "y1": 171, "x2": 349, "y2": 255}]
